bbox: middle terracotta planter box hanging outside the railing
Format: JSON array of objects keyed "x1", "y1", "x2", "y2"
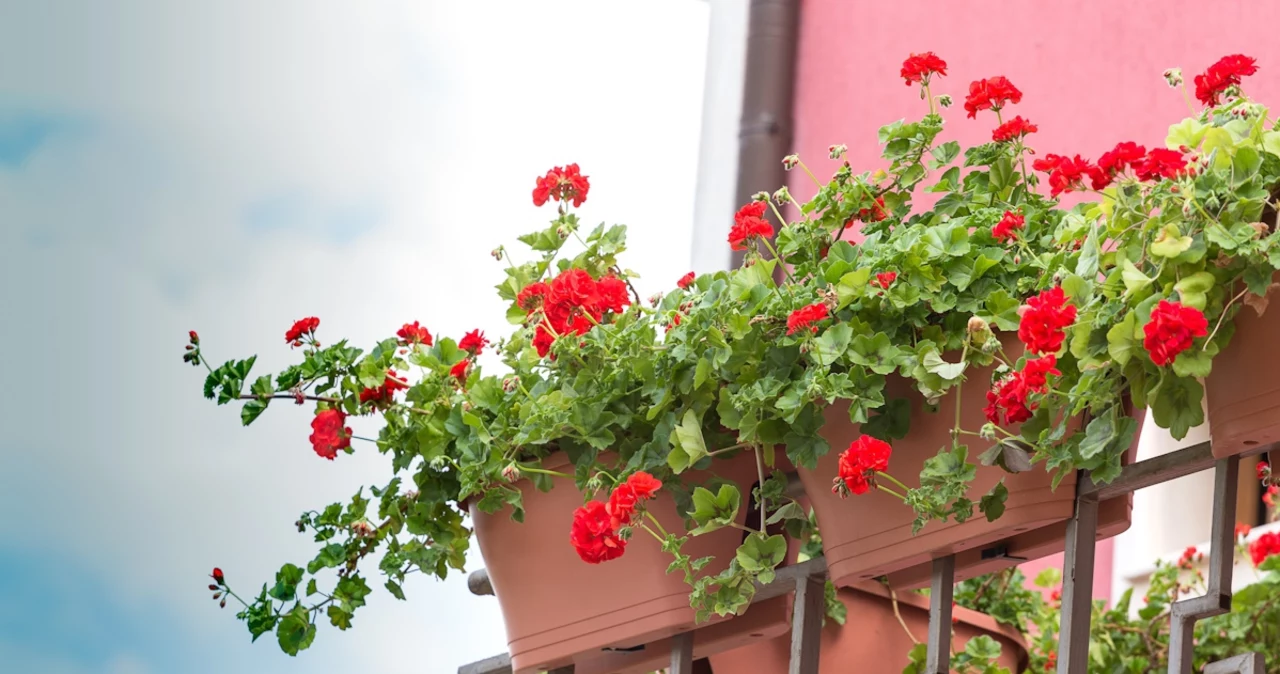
[{"x1": 799, "y1": 355, "x2": 1140, "y2": 588}]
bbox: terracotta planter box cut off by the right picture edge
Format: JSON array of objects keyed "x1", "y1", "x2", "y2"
[{"x1": 1204, "y1": 295, "x2": 1280, "y2": 459}]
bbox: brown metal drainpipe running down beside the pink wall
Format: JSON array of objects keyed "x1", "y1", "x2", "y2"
[{"x1": 732, "y1": 0, "x2": 800, "y2": 267}]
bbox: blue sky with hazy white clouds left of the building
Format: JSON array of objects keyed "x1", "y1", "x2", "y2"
[{"x1": 0, "y1": 0, "x2": 707, "y2": 674}]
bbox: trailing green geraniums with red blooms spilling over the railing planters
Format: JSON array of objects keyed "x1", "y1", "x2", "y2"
[{"x1": 186, "y1": 54, "x2": 1280, "y2": 654}]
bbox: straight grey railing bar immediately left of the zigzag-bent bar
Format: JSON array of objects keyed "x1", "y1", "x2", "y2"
[{"x1": 1057, "y1": 495, "x2": 1098, "y2": 674}]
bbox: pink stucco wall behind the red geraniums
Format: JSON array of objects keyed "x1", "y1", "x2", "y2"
[{"x1": 791, "y1": 0, "x2": 1280, "y2": 599}]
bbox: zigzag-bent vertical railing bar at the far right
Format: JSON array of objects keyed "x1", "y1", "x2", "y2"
[{"x1": 1169, "y1": 457, "x2": 1240, "y2": 674}]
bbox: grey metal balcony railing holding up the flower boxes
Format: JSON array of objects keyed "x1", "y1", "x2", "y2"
[{"x1": 458, "y1": 443, "x2": 1280, "y2": 674}]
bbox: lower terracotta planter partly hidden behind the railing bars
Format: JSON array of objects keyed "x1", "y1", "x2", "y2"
[{"x1": 710, "y1": 583, "x2": 1028, "y2": 674}]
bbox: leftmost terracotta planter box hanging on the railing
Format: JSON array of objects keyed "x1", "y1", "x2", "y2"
[{"x1": 470, "y1": 454, "x2": 788, "y2": 673}]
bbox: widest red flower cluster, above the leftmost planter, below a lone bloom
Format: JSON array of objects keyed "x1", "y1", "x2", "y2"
[{"x1": 514, "y1": 267, "x2": 631, "y2": 357}]
